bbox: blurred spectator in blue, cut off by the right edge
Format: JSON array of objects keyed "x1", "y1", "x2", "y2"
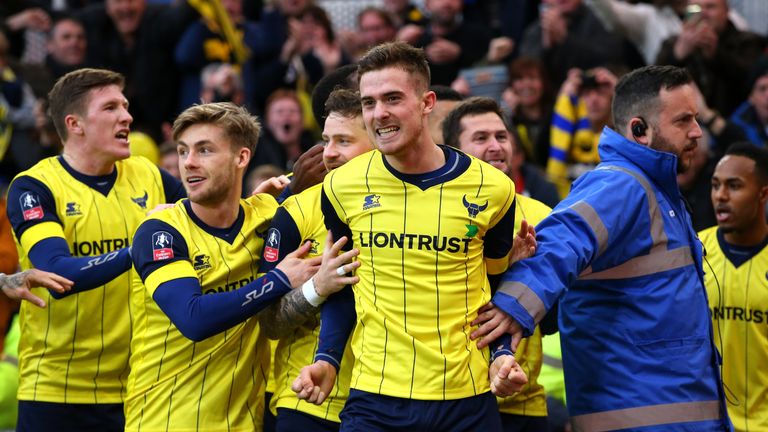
[{"x1": 730, "y1": 56, "x2": 768, "y2": 147}]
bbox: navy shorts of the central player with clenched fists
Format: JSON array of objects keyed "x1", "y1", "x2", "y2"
[{"x1": 340, "y1": 389, "x2": 502, "y2": 432}]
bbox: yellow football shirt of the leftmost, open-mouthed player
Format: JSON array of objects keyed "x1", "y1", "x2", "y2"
[{"x1": 14, "y1": 157, "x2": 166, "y2": 403}]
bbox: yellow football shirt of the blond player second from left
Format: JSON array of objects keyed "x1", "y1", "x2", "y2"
[{"x1": 125, "y1": 195, "x2": 277, "y2": 431}]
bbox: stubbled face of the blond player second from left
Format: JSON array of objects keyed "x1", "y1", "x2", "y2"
[{"x1": 176, "y1": 123, "x2": 247, "y2": 206}]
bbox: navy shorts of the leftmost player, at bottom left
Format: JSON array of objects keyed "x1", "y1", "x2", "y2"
[{"x1": 16, "y1": 401, "x2": 125, "y2": 432}]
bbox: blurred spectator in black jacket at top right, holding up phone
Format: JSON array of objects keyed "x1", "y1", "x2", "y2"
[{"x1": 657, "y1": 0, "x2": 766, "y2": 116}]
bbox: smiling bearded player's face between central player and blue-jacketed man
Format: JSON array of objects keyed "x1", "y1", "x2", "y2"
[{"x1": 459, "y1": 112, "x2": 512, "y2": 175}]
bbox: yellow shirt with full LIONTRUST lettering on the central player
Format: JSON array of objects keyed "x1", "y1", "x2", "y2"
[{"x1": 323, "y1": 147, "x2": 515, "y2": 400}]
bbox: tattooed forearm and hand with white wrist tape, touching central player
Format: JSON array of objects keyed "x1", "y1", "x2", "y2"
[{"x1": 259, "y1": 231, "x2": 360, "y2": 339}]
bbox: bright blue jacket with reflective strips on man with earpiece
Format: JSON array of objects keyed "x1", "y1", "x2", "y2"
[{"x1": 493, "y1": 128, "x2": 731, "y2": 431}]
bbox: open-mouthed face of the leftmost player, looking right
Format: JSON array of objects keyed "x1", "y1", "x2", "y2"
[{"x1": 79, "y1": 85, "x2": 133, "y2": 161}]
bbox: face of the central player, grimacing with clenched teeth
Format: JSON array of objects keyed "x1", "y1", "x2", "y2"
[{"x1": 360, "y1": 67, "x2": 434, "y2": 156}]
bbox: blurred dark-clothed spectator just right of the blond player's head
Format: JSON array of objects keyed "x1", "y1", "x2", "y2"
[{"x1": 249, "y1": 89, "x2": 314, "y2": 171}]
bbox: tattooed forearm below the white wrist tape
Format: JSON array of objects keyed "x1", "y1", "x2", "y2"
[{"x1": 259, "y1": 289, "x2": 320, "y2": 339}]
